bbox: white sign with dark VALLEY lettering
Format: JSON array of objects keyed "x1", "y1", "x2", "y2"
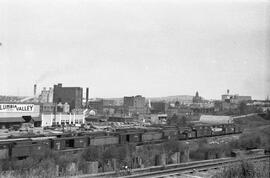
[{"x1": 0, "y1": 104, "x2": 34, "y2": 112}]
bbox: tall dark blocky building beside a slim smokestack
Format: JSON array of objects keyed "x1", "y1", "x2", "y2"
[{"x1": 53, "y1": 83, "x2": 83, "y2": 110}]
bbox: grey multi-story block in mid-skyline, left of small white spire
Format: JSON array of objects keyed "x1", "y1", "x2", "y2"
[{"x1": 124, "y1": 95, "x2": 146, "y2": 114}]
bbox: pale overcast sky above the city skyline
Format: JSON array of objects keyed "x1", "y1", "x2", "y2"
[{"x1": 0, "y1": 0, "x2": 270, "y2": 99}]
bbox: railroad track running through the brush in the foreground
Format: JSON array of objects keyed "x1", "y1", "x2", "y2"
[{"x1": 76, "y1": 155, "x2": 270, "y2": 178}]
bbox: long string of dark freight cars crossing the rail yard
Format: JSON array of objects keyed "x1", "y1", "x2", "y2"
[{"x1": 0, "y1": 124, "x2": 242, "y2": 159}]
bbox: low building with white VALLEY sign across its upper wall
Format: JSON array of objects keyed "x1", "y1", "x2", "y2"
[{"x1": 0, "y1": 102, "x2": 41, "y2": 128}]
